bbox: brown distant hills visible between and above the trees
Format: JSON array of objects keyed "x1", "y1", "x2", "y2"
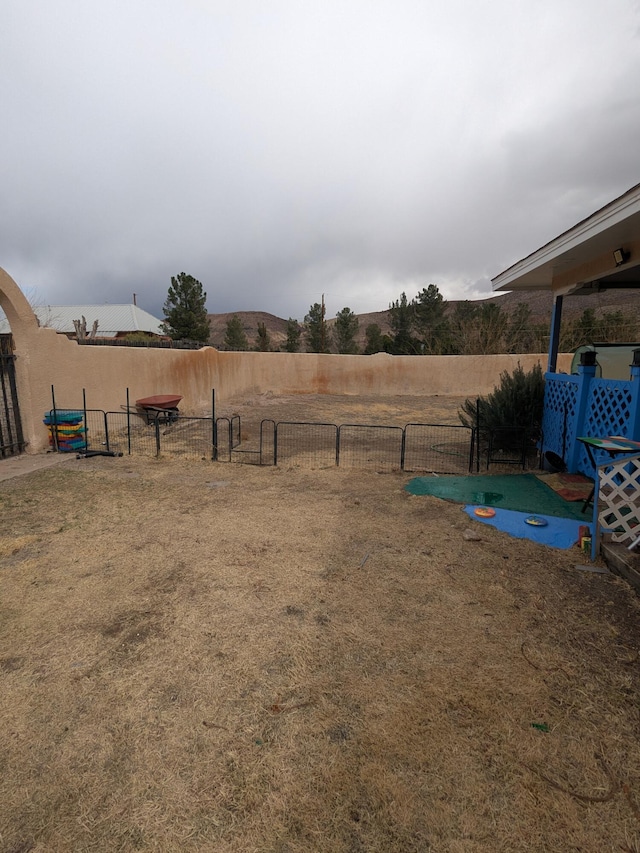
[{"x1": 209, "y1": 290, "x2": 640, "y2": 351}]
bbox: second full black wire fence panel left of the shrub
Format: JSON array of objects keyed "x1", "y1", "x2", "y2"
[{"x1": 337, "y1": 424, "x2": 404, "y2": 471}]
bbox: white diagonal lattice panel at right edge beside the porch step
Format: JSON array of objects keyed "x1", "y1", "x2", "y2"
[{"x1": 592, "y1": 454, "x2": 640, "y2": 557}]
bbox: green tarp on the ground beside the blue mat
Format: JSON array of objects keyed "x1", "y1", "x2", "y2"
[{"x1": 405, "y1": 474, "x2": 591, "y2": 524}]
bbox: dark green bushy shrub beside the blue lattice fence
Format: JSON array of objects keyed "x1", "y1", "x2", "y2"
[{"x1": 458, "y1": 362, "x2": 544, "y2": 439}]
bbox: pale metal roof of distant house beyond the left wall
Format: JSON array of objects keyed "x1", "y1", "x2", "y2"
[{"x1": 0, "y1": 305, "x2": 165, "y2": 338}]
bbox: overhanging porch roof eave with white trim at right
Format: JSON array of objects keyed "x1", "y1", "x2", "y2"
[{"x1": 491, "y1": 184, "x2": 640, "y2": 293}]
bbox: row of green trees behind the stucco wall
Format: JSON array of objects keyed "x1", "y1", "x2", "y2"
[{"x1": 158, "y1": 272, "x2": 639, "y2": 355}]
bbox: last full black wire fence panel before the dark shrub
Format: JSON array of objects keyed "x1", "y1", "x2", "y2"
[{"x1": 403, "y1": 424, "x2": 474, "y2": 474}]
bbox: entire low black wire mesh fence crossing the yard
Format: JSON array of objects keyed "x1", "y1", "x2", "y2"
[{"x1": 46, "y1": 386, "x2": 535, "y2": 474}]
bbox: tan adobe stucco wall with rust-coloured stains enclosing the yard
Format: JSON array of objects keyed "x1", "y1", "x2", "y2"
[{"x1": 0, "y1": 269, "x2": 571, "y2": 452}]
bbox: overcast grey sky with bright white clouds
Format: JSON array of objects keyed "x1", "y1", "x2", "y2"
[{"x1": 0, "y1": 0, "x2": 640, "y2": 320}]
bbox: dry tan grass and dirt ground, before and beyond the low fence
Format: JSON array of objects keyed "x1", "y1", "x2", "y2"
[{"x1": 0, "y1": 395, "x2": 640, "y2": 853}]
